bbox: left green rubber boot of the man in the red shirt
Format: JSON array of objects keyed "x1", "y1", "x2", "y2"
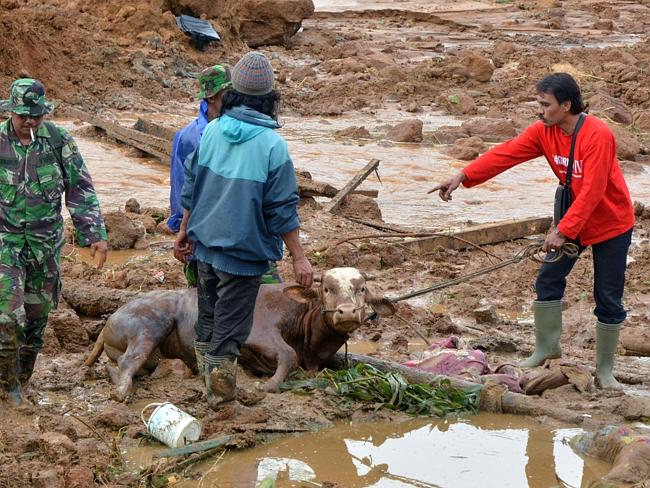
[{"x1": 519, "y1": 300, "x2": 562, "y2": 368}]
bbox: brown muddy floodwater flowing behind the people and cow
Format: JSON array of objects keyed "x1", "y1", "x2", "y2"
[{"x1": 58, "y1": 112, "x2": 650, "y2": 230}]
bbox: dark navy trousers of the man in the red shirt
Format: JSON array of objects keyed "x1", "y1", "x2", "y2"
[{"x1": 535, "y1": 229, "x2": 632, "y2": 324}]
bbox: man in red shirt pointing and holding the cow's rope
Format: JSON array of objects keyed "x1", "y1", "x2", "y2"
[{"x1": 429, "y1": 73, "x2": 634, "y2": 389}]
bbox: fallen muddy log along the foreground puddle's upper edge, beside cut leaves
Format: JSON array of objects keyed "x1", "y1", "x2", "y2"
[{"x1": 326, "y1": 352, "x2": 584, "y2": 424}]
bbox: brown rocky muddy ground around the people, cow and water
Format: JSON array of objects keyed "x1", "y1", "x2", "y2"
[{"x1": 0, "y1": 0, "x2": 650, "y2": 487}]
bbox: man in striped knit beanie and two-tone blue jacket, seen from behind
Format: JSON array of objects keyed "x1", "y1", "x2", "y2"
[{"x1": 174, "y1": 52, "x2": 313, "y2": 410}]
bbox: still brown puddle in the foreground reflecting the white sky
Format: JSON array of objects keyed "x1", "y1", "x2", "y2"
[{"x1": 126, "y1": 413, "x2": 609, "y2": 488}]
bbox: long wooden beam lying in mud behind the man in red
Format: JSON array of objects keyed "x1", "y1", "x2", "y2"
[{"x1": 404, "y1": 217, "x2": 552, "y2": 254}]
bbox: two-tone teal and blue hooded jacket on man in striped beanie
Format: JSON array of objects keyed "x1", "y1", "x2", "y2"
[{"x1": 182, "y1": 106, "x2": 299, "y2": 276}]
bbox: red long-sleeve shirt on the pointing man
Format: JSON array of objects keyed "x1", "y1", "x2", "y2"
[{"x1": 463, "y1": 116, "x2": 634, "y2": 245}]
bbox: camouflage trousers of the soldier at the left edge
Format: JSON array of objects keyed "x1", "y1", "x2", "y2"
[{"x1": 0, "y1": 246, "x2": 61, "y2": 385}]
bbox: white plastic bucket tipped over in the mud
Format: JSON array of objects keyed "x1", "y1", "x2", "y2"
[{"x1": 140, "y1": 402, "x2": 201, "y2": 448}]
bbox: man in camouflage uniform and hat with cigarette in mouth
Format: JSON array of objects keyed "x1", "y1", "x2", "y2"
[{"x1": 0, "y1": 78, "x2": 107, "y2": 409}]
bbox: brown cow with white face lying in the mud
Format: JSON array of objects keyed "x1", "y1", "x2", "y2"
[{"x1": 85, "y1": 268, "x2": 395, "y2": 401}]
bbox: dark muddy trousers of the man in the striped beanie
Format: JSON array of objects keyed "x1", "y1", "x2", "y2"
[{"x1": 196, "y1": 261, "x2": 260, "y2": 359}]
